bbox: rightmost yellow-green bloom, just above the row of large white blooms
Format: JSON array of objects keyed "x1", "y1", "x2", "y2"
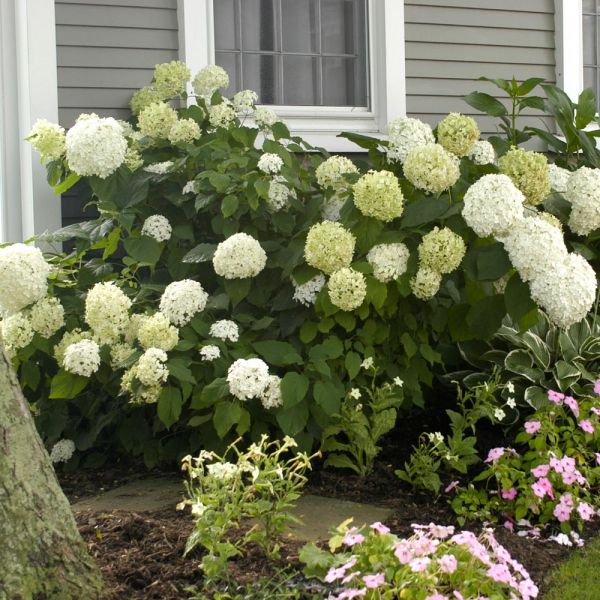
[{"x1": 498, "y1": 148, "x2": 550, "y2": 206}]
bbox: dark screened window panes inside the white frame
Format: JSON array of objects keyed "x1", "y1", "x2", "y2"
[{"x1": 214, "y1": 0, "x2": 369, "y2": 107}]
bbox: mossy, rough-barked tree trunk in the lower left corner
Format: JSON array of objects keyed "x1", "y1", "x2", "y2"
[{"x1": 0, "y1": 343, "x2": 102, "y2": 600}]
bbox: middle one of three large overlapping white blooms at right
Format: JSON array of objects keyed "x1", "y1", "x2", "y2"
[{"x1": 501, "y1": 217, "x2": 567, "y2": 281}]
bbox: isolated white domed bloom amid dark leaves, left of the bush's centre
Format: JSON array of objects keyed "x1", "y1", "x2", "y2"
[{"x1": 213, "y1": 233, "x2": 267, "y2": 279}]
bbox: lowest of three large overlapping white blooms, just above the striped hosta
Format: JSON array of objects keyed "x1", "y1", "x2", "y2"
[{"x1": 530, "y1": 253, "x2": 597, "y2": 327}]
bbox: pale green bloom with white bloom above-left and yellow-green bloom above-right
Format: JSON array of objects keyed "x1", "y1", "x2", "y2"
[{"x1": 404, "y1": 144, "x2": 460, "y2": 194}]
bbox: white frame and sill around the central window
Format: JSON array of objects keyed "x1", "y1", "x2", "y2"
[{"x1": 178, "y1": 0, "x2": 406, "y2": 152}]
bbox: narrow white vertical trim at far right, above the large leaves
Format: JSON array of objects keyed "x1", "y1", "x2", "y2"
[{"x1": 554, "y1": 0, "x2": 583, "y2": 102}]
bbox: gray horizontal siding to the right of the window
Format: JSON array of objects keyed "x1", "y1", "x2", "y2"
[{"x1": 405, "y1": 0, "x2": 556, "y2": 134}]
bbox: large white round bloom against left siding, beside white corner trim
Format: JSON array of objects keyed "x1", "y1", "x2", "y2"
[{"x1": 66, "y1": 114, "x2": 127, "y2": 179}]
